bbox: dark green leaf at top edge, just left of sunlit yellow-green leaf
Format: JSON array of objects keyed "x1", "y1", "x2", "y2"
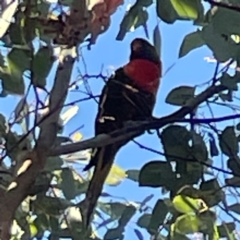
[{"x1": 157, "y1": 0, "x2": 179, "y2": 23}]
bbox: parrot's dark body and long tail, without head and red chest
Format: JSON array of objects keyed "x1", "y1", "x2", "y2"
[{"x1": 81, "y1": 69, "x2": 155, "y2": 229}]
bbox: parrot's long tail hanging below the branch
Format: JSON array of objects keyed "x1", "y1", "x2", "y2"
[{"x1": 81, "y1": 146, "x2": 119, "y2": 228}]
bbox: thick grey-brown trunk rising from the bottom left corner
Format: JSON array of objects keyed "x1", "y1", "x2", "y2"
[{"x1": 0, "y1": 59, "x2": 73, "y2": 240}]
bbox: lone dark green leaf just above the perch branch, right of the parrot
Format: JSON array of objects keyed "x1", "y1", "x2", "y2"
[{"x1": 165, "y1": 86, "x2": 195, "y2": 106}]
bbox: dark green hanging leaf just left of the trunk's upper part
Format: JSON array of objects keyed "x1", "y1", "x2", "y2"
[{"x1": 32, "y1": 47, "x2": 54, "y2": 88}]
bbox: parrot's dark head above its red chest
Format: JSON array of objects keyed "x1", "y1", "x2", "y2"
[{"x1": 130, "y1": 38, "x2": 160, "y2": 64}]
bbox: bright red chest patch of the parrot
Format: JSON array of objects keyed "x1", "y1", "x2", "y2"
[{"x1": 124, "y1": 59, "x2": 161, "y2": 95}]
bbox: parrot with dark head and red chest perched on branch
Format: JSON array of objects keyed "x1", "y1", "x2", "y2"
[{"x1": 81, "y1": 38, "x2": 162, "y2": 228}]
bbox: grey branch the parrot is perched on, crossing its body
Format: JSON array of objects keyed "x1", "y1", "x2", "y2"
[{"x1": 50, "y1": 85, "x2": 227, "y2": 156}]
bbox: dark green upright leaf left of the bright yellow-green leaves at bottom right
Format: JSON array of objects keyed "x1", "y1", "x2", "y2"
[{"x1": 148, "y1": 199, "x2": 168, "y2": 234}]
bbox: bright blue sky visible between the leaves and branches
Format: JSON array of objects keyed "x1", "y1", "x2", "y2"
[{"x1": 0, "y1": 0, "x2": 239, "y2": 239}]
